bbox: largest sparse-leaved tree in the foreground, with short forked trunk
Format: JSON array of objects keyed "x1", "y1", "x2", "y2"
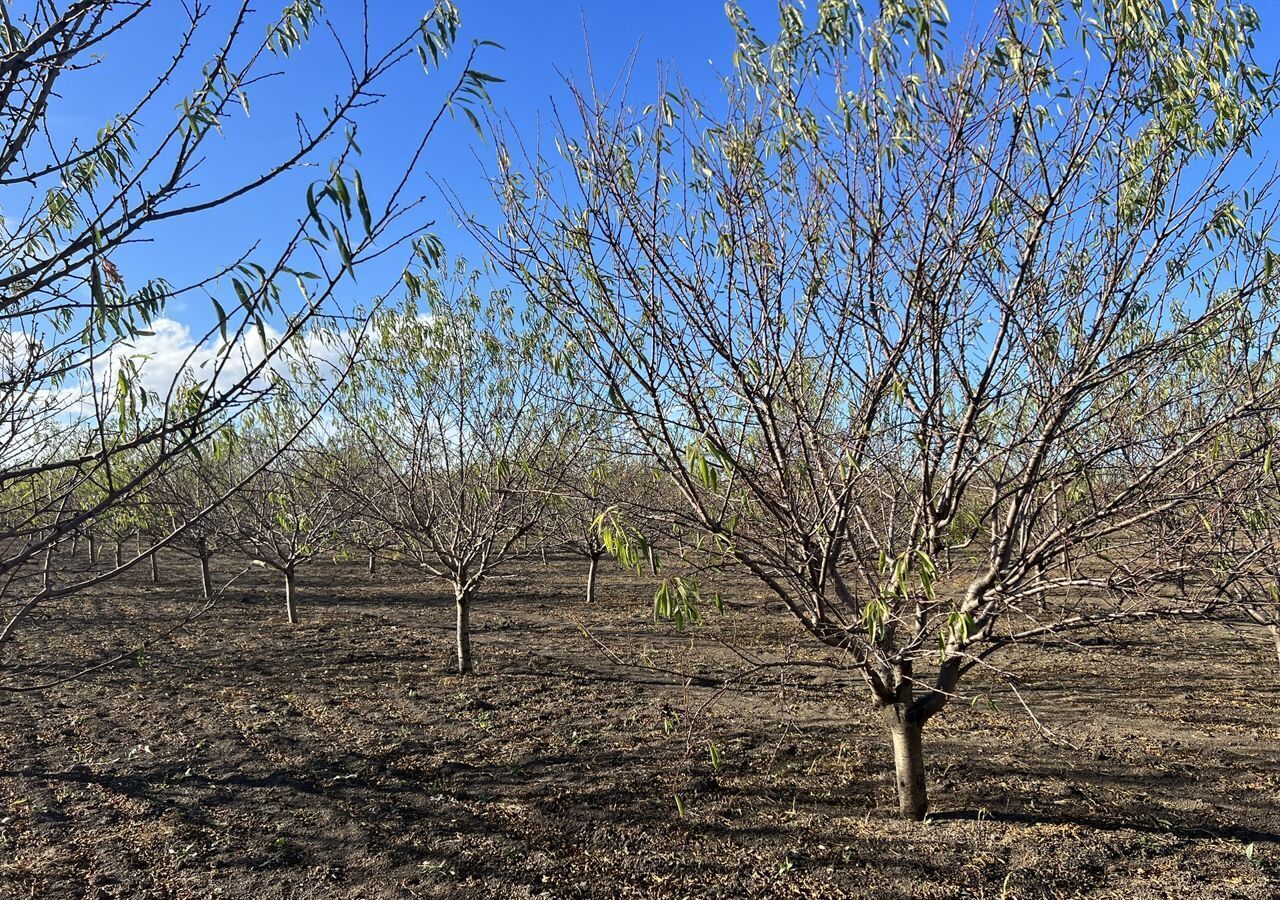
[{"x1": 472, "y1": 0, "x2": 1280, "y2": 819}]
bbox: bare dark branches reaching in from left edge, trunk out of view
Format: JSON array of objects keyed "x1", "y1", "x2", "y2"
[{"x1": 0, "y1": 0, "x2": 493, "y2": 670}]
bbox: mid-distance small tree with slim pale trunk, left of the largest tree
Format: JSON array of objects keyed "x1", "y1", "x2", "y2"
[{"x1": 338, "y1": 262, "x2": 584, "y2": 673}]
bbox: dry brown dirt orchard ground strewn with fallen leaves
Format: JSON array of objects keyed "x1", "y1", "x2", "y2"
[{"x1": 0, "y1": 561, "x2": 1280, "y2": 900}]
